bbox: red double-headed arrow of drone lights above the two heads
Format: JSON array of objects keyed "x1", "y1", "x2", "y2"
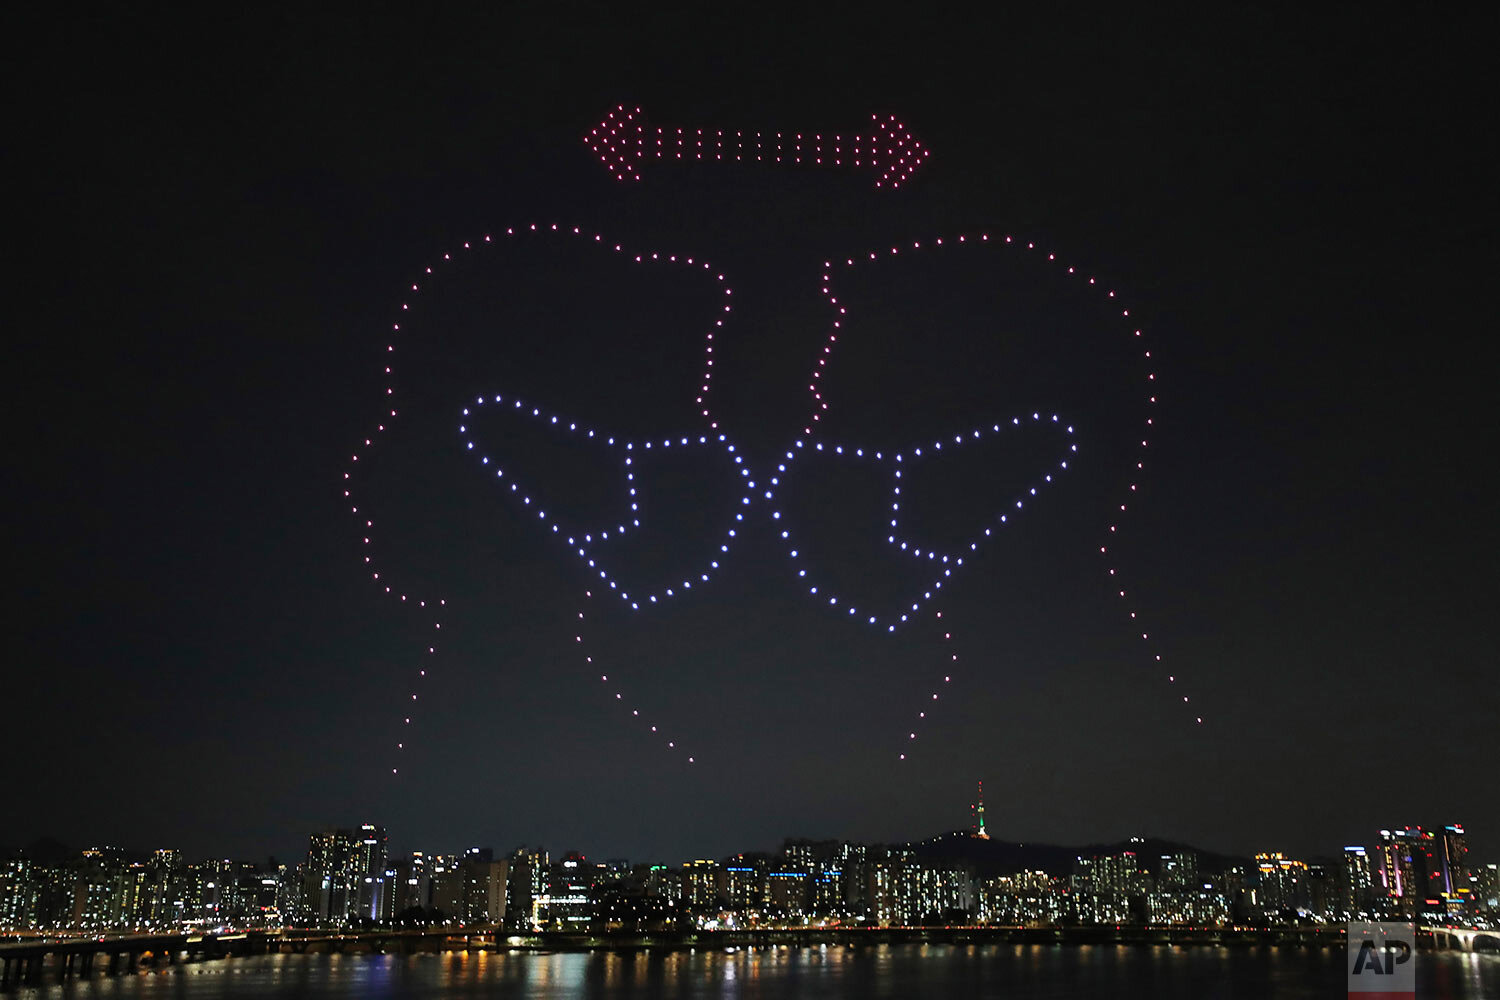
[{"x1": 584, "y1": 105, "x2": 929, "y2": 187}]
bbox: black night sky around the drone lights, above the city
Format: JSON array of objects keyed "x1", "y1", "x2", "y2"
[{"x1": 11, "y1": 4, "x2": 1500, "y2": 862}]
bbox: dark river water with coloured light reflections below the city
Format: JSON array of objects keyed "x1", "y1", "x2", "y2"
[{"x1": 8, "y1": 945, "x2": 1500, "y2": 1000}]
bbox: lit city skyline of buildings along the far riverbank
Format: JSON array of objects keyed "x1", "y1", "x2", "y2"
[{"x1": 0, "y1": 823, "x2": 1500, "y2": 933}]
